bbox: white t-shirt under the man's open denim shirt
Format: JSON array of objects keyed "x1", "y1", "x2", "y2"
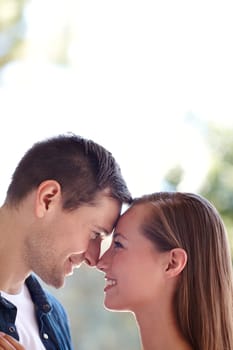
[{"x1": 1, "y1": 284, "x2": 45, "y2": 350}]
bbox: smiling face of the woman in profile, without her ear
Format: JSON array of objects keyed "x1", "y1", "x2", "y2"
[{"x1": 97, "y1": 204, "x2": 168, "y2": 312}]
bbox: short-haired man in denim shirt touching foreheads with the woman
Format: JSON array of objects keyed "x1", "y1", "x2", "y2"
[{"x1": 0, "y1": 135, "x2": 131, "y2": 350}]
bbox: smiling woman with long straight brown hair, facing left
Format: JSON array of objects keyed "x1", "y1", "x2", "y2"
[{"x1": 97, "y1": 192, "x2": 233, "y2": 350}]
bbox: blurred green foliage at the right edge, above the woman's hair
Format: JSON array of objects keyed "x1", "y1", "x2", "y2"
[{"x1": 165, "y1": 123, "x2": 233, "y2": 252}]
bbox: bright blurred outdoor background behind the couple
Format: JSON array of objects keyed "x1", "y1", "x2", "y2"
[{"x1": 0, "y1": 0, "x2": 233, "y2": 350}]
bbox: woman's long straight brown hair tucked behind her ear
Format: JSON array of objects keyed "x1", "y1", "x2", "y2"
[{"x1": 133, "y1": 192, "x2": 233, "y2": 350}]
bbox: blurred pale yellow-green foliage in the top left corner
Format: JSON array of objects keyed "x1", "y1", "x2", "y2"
[{"x1": 0, "y1": 0, "x2": 27, "y2": 67}]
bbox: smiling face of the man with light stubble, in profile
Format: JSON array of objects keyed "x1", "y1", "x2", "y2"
[{"x1": 25, "y1": 192, "x2": 121, "y2": 288}]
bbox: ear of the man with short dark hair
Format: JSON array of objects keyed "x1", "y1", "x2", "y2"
[{"x1": 35, "y1": 180, "x2": 61, "y2": 218}]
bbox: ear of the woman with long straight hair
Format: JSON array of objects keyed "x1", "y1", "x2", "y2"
[{"x1": 166, "y1": 248, "x2": 188, "y2": 278}]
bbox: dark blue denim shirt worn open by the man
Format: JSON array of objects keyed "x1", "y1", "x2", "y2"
[{"x1": 0, "y1": 275, "x2": 73, "y2": 350}]
